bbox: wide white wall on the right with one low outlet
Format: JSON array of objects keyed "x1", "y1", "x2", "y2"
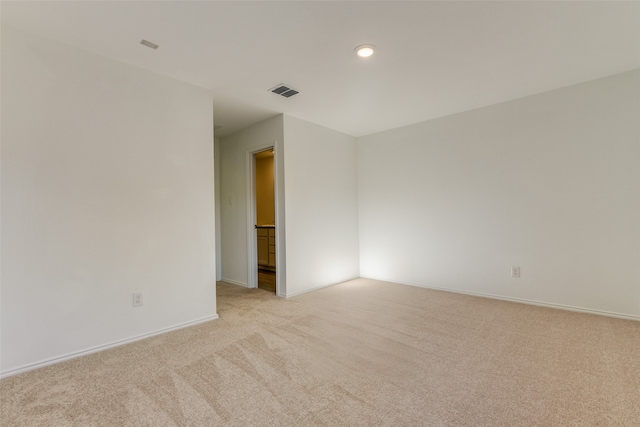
[{"x1": 358, "y1": 70, "x2": 640, "y2": 316}]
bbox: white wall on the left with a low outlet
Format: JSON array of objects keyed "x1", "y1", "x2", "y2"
[{"x1": 0, "y1": 26, "x2": 217, "y2": 374}]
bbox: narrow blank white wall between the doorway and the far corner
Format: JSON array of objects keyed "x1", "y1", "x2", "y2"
[{"x1": 284, "y1": 115, "x2": 359, "y2": 296}]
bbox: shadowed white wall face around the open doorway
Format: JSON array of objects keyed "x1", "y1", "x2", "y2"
[{"x1": 220, "y1": 115, "x2": 284, "y2": 289}]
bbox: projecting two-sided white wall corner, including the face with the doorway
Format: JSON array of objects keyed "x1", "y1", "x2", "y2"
[{"x1": 220, "y1": 115, "x2": 359, "y2": 296}]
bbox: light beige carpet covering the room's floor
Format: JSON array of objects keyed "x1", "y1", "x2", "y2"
[{"x1": 0, "y1": 279, "x2": 640, "y2": 427}]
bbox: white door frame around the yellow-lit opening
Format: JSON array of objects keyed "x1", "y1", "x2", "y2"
[{"x1": 246, "y1": 141, "x2": 286, "y2": 296}]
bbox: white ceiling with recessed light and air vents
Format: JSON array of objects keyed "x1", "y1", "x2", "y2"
[{"x1": 0, "y1": 0, "x2": 640, "y2": 136}]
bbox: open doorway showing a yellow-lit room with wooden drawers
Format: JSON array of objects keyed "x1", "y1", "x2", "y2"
[{"x1": 252, "y1": 147, "x2": 277, "y2": 293}]
